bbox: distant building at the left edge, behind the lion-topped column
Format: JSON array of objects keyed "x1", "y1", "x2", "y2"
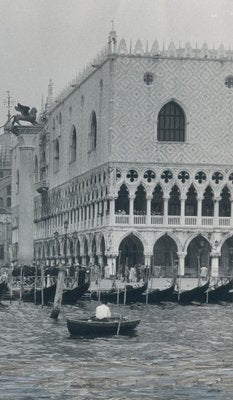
[{"x1": 0, "y1": 132, "x2": 12, "y2": 266}]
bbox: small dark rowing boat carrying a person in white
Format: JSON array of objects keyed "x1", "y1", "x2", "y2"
[{"x1": 67, "y1": 317, "x2": 140, "y2": 336}]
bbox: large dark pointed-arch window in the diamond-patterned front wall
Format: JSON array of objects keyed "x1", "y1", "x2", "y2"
[{"x1": 157, "y1": 101, "x2": 185, "y2": 142}]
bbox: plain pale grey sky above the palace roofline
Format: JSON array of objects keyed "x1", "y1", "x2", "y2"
[{"x1": 0, "y1": 0, "x2": 233, "y2": 125}]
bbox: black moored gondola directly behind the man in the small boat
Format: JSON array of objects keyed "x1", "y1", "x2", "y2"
[{"x1": 91, "y1": 283, "x2": 147, "y2": 304}]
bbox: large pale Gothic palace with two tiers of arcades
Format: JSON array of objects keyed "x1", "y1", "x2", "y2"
[{"x1": 10, "y1": 31, "x2": 233, "y2": 276}]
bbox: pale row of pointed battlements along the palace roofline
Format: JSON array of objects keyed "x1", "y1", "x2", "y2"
[{"x1": 49, "y1": 35, "x2": 233, "y2": 111}]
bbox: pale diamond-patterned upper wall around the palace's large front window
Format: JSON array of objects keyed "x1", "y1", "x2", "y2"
[{"x1": 111, "y1": 54, "x2": 233, "y2": 164}]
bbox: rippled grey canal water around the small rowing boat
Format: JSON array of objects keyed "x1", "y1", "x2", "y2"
[{"x1": 0, "y1": 301, "x2": 233, "y2": 400}]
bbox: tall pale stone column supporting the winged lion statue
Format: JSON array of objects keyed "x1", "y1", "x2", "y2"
[{"x1": 15, "y1": 125, "x2": 43, "y2": 265}]
